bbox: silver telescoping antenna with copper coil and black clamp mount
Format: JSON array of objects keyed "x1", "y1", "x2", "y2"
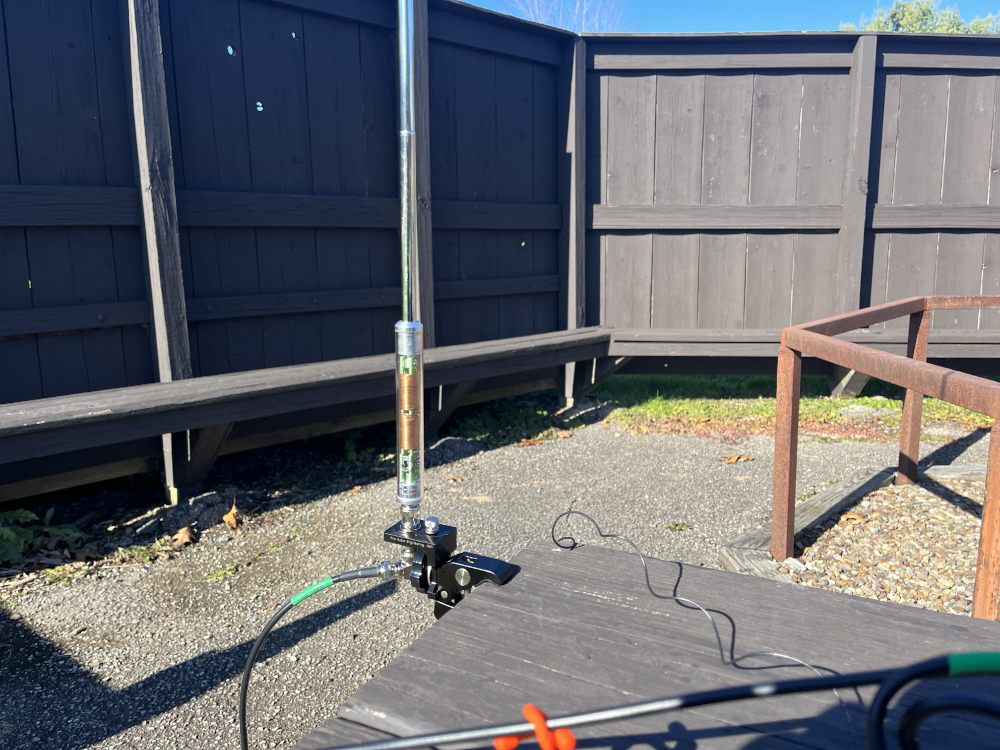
[{"x1": 384, "y1": 0, "x2": 516, "y2": 617}]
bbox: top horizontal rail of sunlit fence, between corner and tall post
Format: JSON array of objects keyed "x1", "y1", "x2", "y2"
[{"x1": 594, "y1": 52, "x2": 851, "y2": 70}]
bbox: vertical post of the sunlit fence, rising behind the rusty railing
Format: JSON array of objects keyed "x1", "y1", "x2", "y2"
[{"x1": 836, "y1": 35, "x2": 878, "y2": 312}]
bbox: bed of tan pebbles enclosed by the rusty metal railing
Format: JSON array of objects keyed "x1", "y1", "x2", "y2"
[{"x1": 780, "y1": 480, "x2": 986, "y2": 614}]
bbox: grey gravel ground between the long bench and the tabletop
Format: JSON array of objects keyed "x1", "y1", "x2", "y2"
[{"x1": 0, "y1": 423, "x2": 987, "y2": 750}]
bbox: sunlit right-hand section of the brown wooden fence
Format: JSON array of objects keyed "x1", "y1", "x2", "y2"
[{"x1": 586, "y1": 34, "x2": 1000, "y2": 344}]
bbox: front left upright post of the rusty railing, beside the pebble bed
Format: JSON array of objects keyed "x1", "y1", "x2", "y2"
[{"x1": 771, "y1": 346, "x2": 802, "y2": 560}]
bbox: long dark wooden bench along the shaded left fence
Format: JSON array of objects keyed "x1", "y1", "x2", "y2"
[{"x1": 0, "y1": 328, "x2": 610, "y2": 501}]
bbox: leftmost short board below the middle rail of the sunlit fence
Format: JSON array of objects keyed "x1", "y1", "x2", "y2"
[{"x1": 604, "y1": 234, "x2": 653, "y2": 328}]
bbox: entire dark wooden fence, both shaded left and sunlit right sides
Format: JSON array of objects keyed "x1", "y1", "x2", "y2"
[{"x1": 0, "y1": 0, "x2": 1000, "y2": 506}]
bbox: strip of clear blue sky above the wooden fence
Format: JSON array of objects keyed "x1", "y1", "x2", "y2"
[{"x1": 466, "y1": 0, "x2": 1000, "y2": 33}]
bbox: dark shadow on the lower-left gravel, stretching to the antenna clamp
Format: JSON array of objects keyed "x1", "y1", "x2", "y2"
[{"x1": 0, "y1": 581, "x2": 396, "y2": 750}]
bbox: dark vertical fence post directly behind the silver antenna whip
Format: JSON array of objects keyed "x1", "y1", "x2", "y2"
[{"x1": 413, "y1": 0, "x2": 435, "y2": 347}]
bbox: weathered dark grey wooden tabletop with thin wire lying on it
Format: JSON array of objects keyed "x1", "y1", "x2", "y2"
[{"x1": 302, "y1": 537, "x2": 1000, "y2": 750}]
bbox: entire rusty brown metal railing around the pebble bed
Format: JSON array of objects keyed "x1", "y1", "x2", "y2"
[{"x1": 771, "y1": 296, "x2": 1000, "y2": 620}]
